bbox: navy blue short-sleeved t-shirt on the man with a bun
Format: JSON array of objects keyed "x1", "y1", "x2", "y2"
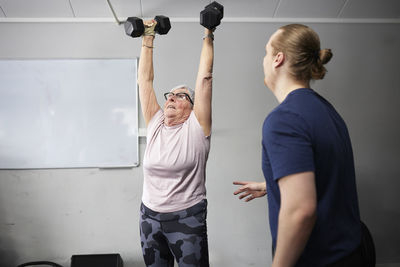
[{"x1": 262, "y1": 88, "x2": 361, "y2": 267}]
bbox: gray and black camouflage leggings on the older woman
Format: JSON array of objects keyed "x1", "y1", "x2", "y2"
[{"x1": 140, "y1": 200, "x2": 209, "y2": 267}]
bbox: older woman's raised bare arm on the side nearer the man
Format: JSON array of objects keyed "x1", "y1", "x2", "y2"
[{"x1": 193, "y1": 29, "x2": 214, "y2": 136}]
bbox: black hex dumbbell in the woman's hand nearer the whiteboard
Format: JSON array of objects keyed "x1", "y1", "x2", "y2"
[{"x1": 124, "y1": 16, "x2": 171, "y2": 37}]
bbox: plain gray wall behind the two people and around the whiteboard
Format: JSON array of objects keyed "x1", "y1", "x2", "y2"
[{"x1": 0, "y1": 23, "x2": 400, "y2": 267}]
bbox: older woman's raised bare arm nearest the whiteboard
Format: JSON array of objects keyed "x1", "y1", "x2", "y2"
[{"x1": 138, "y1": 28, "x2": 160, "y2": 126}]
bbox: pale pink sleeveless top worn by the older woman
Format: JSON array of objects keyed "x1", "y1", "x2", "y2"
[{"x1": 142, "y1": 109, "x2": 210, "y2": 212}]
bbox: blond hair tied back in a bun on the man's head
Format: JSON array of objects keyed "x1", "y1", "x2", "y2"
[{"x1": 271, "y1": 24, "x2": 332, "y2": 81}]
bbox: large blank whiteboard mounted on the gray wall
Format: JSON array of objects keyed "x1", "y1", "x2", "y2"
[{"x1": 0, "y1": 59, "x2": 139, "y2": 169}]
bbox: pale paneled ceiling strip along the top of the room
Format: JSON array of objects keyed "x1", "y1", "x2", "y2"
[{"x1": 0, "y1": 0, "x2": 400, "y2": 23}]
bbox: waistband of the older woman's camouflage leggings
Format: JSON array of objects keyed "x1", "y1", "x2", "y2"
[{"x1": 140, "y1": 199, "x2": 207, "y2": 222}]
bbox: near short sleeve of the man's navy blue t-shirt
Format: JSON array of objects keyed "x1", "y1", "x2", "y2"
[{"x1": 263, "y1": 110, "x2": 315, "y2": 180}]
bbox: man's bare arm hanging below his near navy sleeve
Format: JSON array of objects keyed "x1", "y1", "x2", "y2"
[{"x1": 272, "y1": 172, "x2": 317, "y2": 267}]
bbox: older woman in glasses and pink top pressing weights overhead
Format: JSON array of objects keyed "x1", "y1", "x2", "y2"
[{"x1": 138, "y1": 21, "x2": 214, "y2": 267}]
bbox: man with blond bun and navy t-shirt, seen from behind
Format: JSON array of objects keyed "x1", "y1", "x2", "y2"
[{"x1": 235, "y1": 24, "x2": 363, "y2": 267}]
